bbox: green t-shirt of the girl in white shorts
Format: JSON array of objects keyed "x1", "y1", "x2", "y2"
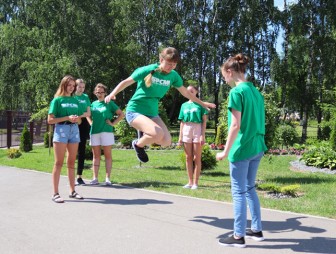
[{"x1": 90, "y1": 100, "x2": 119, "y2": 134}]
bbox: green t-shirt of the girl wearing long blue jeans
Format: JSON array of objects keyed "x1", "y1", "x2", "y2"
[{"x1": 228, "y1": 82, "x2": 267, "y2": 162}]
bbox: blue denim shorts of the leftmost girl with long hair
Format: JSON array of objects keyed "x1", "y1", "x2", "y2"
[{"x1": 53, "y1": 124, "x2": 80, "y2": 144}]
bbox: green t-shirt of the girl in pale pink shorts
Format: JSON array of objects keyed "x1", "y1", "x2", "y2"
[{"x1": 178, "y1": 101, "x2": 208, "y2": 123}]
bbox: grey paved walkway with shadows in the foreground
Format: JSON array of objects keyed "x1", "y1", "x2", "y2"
[{"x1": 0, "y1": 166, "x2": 336, "y2": 254}]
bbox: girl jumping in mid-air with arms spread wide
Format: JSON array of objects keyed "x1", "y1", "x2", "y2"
[{"x1": 105, "y1": 47, "x2": 216, "y2": 162}]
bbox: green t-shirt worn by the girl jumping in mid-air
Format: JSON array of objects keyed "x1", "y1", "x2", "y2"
[{"x1": 126, "y1": 64, "x2": 183, "y2": 116}]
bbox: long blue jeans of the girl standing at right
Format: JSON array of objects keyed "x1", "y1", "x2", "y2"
[{"x1": 230, "y1": 152, "x2": 264, "y2": 237}]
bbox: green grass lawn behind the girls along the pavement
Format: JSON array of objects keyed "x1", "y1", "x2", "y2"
[{"x1": 0, "y1": 146, "x2": 336, "y2": 219}]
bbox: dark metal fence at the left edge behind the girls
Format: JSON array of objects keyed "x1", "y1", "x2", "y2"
[{"x1": 0, "y1": 110, "x2": 48, "y2": 148}]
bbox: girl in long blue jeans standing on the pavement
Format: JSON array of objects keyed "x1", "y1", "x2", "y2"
[{"x1": 216, "y1": 54, "x2": 267, "y2": 248}]
